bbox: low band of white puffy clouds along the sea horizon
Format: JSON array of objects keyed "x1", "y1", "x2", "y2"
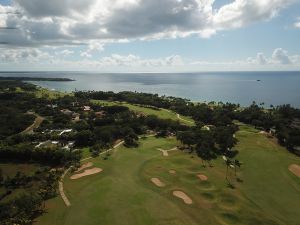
[{"x1": 0, "y1": 48, "x2": 300, "y2": 72}]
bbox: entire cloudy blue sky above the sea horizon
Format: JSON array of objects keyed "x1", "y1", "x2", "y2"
[{"x1": 0, "y1": 0, "x2": 300, "y2": 72}]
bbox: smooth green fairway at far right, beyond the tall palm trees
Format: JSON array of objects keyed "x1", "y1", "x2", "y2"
[{"x1": 237, "y1": 125, "x2": 300, "y2": 225}]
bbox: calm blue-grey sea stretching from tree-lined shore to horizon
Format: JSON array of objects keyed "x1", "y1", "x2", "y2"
[{"x1": 0, "y1": 72, "x2": 300, "y2": 108}]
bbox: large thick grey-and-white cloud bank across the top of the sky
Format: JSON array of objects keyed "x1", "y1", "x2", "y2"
[{"x1": 0, "y1": 0, "x2": 294, "y2": 48}]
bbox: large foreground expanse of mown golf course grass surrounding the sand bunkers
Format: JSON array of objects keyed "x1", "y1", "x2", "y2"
[{"x1": 38, "y1": 126, "x2": 300, "y2": 225}]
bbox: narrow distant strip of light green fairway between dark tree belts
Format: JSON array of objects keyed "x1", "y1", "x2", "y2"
[{"x1": 91, "y1": 100, "x2": 195, "y2": 126}]
